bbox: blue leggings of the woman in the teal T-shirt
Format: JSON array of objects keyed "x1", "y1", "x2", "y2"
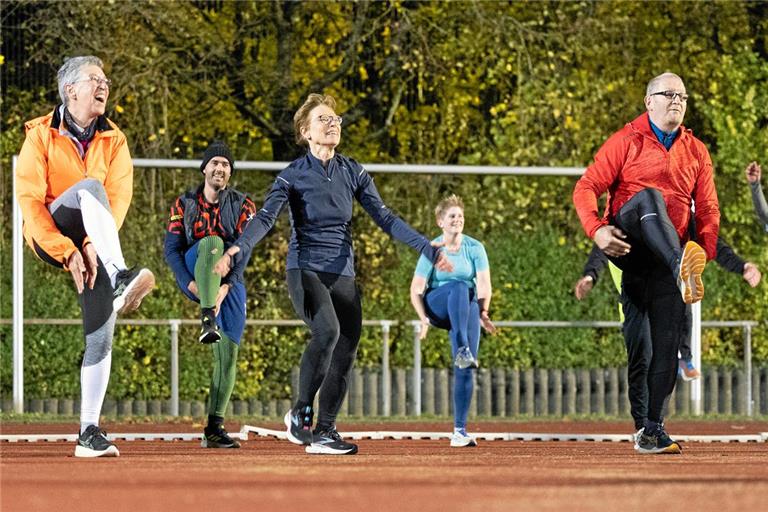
[{"x1": 424, "y1": 281, "x2": 480, "y2": 428}]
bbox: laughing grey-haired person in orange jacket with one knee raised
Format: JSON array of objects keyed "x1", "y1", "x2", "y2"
[{"x1": 16, "y1": 56, "x2": 155, "y2": 457}]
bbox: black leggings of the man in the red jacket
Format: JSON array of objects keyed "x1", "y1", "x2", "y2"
[{"x1": 609, "y1": 188, "x2": 690, "y2": 429}]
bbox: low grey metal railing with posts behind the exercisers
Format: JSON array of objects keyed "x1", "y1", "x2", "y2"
[{"x1": 0, "y1": 318, "x2": 757, "y2": 416}]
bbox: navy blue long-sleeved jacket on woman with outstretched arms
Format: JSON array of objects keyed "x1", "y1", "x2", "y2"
[{"x1": 234, "y1": 152, "x2": 438, "y2": 276}]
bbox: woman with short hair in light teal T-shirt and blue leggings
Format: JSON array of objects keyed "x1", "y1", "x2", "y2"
[{"x1": 411, "y1": 195, "x2": 496, "y2": 447}]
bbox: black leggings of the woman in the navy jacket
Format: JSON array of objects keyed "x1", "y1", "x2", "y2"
[{"x1": 288, "y1": 270, "x2": 363, "y2": 427}]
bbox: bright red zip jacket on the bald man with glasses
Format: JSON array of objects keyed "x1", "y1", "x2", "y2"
[{"x1": 573, "y1": 113, "x2": 720, "y2": 259}]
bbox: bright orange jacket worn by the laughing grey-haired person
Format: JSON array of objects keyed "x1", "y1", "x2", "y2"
[{"x1": 16, "y1": 107, "x2": 133, "y2": 267}]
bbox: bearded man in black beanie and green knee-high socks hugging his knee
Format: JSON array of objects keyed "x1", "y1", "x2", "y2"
[{"x1": 165, "y1": 141, "x2": 256, "y2": 448}]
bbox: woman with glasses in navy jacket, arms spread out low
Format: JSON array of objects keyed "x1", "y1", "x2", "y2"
[{"x1": 215, "y1": 94, "x2": 452, "y2": 454}]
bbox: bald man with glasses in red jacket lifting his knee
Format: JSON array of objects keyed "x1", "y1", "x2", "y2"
[{"x1": 573, "y1": 73, "x2": 720, "y2": 453}]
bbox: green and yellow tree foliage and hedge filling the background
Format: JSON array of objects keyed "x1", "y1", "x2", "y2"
[{"x1": 0, "y1": 1, "x2": 768, "y2": 398}]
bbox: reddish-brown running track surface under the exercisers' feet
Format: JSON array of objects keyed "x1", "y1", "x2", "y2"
[{"x1": 0, "y1": 420, "x2": 768, "y2": 512}]
